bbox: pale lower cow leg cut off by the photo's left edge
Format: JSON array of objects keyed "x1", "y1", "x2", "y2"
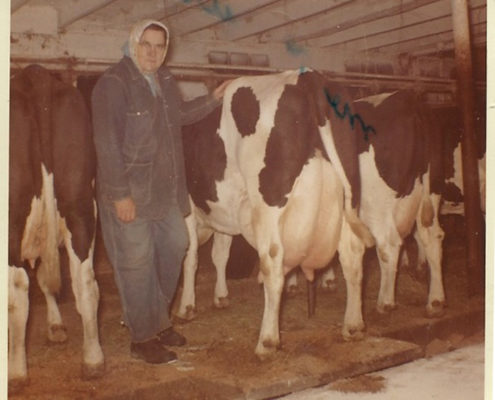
[{"x1": 8, "y1": 266, "x2": 29, "y2": 386}]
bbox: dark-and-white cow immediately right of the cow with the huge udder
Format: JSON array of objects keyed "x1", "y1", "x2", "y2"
[{"x1": 353, "y1": 91, "x2": 445, "y2": 317}]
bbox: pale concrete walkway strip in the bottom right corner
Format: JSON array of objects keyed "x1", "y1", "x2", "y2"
[{"x1": 280, "y1": 336, "x2": 486, "y2": 400}]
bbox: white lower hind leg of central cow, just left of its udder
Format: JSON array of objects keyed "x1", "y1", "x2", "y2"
[{"x1": 255, "y1": 238, "x2": 284, "y2": 359}]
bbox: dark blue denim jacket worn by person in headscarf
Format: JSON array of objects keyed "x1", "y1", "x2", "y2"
[{"x1": 92, "y1": 56, "x2": 219, "y2": 219}]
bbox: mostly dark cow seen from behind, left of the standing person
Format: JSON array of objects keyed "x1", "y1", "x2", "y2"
[{"x1": 8, "y1": 66, "x2": 104, "y2": 386}]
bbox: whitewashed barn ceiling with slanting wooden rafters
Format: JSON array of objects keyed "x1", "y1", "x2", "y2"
[{"x1": 11, "y1": 0, "x2": 486, "y2": 54}]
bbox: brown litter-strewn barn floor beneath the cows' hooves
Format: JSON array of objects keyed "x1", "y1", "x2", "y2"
[{"x1": 9, "y1": 217, "x2": 485, "y2": 400}]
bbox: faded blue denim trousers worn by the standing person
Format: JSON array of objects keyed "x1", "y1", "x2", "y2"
[{"x1": 98, "y1": 201, "x2": 189, "y2": 342}]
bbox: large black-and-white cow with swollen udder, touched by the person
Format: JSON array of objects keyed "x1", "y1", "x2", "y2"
[{"x1": 177, "y1": 71, "x2": 370, "y2": 357}]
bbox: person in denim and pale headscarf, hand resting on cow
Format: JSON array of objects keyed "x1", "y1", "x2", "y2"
[{"x1": 92, "y1": 20, "x2": 231, "y2": 364}]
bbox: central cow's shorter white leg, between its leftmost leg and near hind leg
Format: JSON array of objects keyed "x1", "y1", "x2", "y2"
[{"x1": 211, "y1": 232, "x2": 232, "y2": 308}]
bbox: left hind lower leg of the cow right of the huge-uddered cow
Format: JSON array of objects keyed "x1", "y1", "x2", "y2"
[{"x1": 376, "y1": 234, "x2": 402, "y2": 314}]
